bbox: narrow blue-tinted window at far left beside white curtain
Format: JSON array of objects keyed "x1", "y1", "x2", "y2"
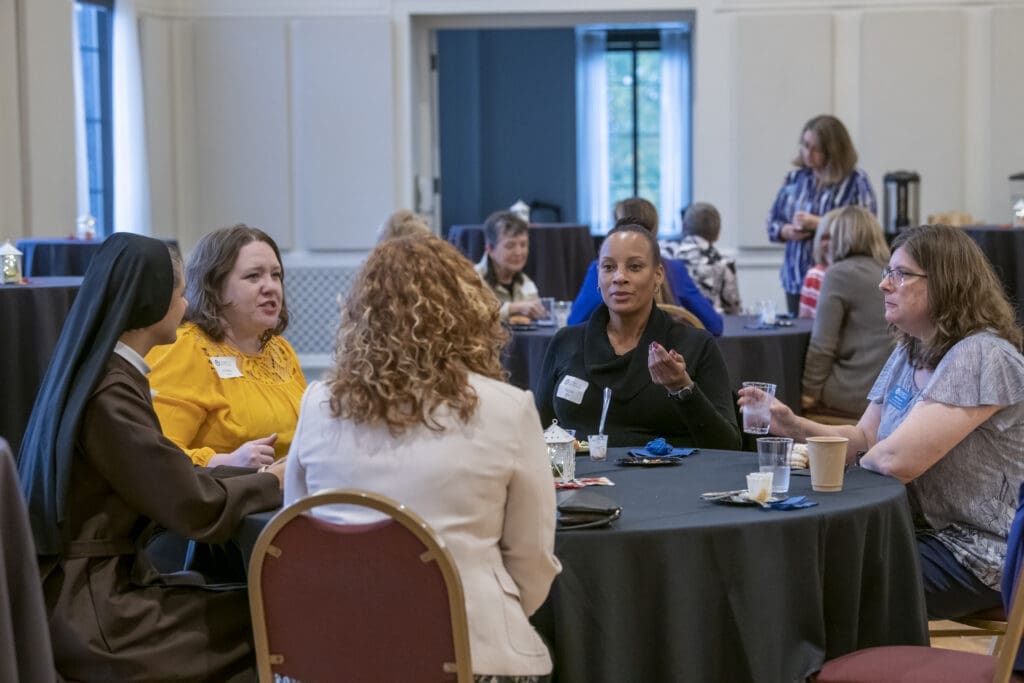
[{"x1": 74, "y1": 0, "x2": 114, "y2": 236}]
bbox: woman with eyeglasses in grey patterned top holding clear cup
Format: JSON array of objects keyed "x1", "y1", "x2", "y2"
[{"x1": 739, "y1": 225, "x2": 1024, "y2": 618}]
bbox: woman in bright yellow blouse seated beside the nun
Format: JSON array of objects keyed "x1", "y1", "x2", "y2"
[{"x1": 145, "y1": 225, "x2": 306, "y2": 467}]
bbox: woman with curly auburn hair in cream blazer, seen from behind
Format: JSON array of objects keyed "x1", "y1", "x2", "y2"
[{"x1": 285, "y1": 236, "x2": 560, "y2": 681}]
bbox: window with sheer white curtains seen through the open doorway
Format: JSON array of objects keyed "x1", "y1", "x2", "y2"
[{"x1": 577, "y1": 25, "x2": 692, "y2": 237}]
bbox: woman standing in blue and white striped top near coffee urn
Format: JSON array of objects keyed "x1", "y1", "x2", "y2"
[{"x1": 768, "y1": 114, "x2": 878, "y2": 315}]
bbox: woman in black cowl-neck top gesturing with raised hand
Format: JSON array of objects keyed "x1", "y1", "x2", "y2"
[{"x1": 537, "y1": 225, "x2": 740, "y2": 449}]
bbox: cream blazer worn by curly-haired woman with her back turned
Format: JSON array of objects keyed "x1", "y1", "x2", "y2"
[{"x1": 285, "y1": 374, "x2": 561, "y2": 676}]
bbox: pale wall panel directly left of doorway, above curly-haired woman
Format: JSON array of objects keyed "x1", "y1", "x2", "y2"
[{"x1": 292, "y1": 16, "x2": 395, "y2": 250}]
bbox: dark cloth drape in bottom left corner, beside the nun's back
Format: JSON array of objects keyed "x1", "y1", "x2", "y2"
[{"x1": 0, "y1": 438, "x2": 55, "y2": 682}]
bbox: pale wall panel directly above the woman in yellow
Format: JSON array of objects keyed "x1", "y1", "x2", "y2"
[{"x1": 192, "y1": 18, "x2": 293, "y2": 249}]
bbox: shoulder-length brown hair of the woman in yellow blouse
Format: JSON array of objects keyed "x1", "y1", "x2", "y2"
[{"x1": 185, "y1": 223, "x2": 288, "y2": 346}]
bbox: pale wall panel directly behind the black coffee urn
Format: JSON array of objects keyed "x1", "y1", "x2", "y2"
[{"x1": 857, "y1": 10, "x2": 967, "y2": 221}]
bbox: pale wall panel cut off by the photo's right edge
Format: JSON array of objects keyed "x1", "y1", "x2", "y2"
[{"x1": 983, "y1": 7, "x2": 1024, "y2": 223}]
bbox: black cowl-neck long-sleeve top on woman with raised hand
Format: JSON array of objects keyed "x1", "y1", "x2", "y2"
[{"x1": 537, "y1": 305, "x2": 741, "y2": 450}]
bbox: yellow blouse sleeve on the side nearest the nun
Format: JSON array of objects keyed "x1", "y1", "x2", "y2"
[{"x1": 145, "y1": 328, "x2": 222, "y2": 466}]
